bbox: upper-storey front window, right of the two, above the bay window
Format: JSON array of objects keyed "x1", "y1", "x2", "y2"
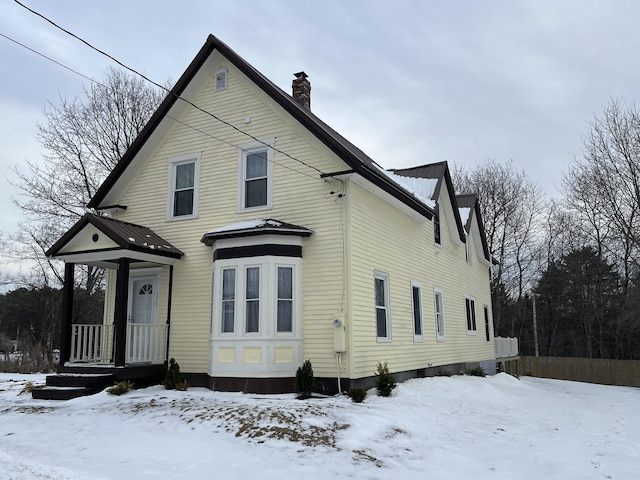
[{"x1": 238, "y1": 140, "x2": 273, "y2": 211}]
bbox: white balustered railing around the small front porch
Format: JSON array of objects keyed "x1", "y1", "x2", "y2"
[{"x1": 69, "y1": 323, "x2": 168, "y2": 364}]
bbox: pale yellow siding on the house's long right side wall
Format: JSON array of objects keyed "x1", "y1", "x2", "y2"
[{"x1": 349, "y1": 180, "x2": 493, "y2": 378}]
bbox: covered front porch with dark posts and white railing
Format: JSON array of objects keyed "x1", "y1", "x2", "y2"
[{"x1": 39, "y1": 214, "x2": 182, "y2": 398}]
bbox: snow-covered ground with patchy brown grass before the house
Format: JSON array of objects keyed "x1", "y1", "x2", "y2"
[{"x1": 0, "y1": 373, "x2": 640, "y2": 480}]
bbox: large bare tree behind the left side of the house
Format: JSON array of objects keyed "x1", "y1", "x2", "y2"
[{"x1": 13, "y1": 68, "x2": 164, "y2": 291}]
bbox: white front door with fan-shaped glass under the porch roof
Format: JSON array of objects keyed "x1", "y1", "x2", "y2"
[{"x1": 127, "y1": 275, "x2": 158, "y2": 362}]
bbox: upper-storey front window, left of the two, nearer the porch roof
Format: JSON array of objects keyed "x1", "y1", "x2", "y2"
[{"x1": 167, "y1": 154, "x2": 200, "y2": 220}]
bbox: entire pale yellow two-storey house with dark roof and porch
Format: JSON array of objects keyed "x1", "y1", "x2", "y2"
[{"x1": 43, "y1": 36, "x2": 495, "y2": 393}]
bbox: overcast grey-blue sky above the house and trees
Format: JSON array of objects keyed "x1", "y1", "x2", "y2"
[{"x1": 0, "y1": 0, "x2": 640, "y2": 262}]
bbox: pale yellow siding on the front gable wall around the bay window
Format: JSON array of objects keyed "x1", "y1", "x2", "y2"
[{"x1": 111, "y1": 56, "x2": 345, "y2": 376}]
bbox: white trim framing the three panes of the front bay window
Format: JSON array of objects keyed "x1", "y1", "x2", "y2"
[{"x1": 211, "y1": 256, "x2": 302, "y2": 340}]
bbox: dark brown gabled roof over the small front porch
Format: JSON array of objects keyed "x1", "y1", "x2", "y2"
[{"x1": 46, "y1": 213, "x2": 183, "y2": 258}]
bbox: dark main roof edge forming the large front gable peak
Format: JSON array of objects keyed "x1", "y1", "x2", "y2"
[{"x1": 87, "y1": 35, "x2": 434, "y2": 219}]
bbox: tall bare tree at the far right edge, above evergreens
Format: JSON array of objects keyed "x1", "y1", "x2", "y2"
[{"x1": 563, "y1": 100, "x2": 640, "y2": 290}]
